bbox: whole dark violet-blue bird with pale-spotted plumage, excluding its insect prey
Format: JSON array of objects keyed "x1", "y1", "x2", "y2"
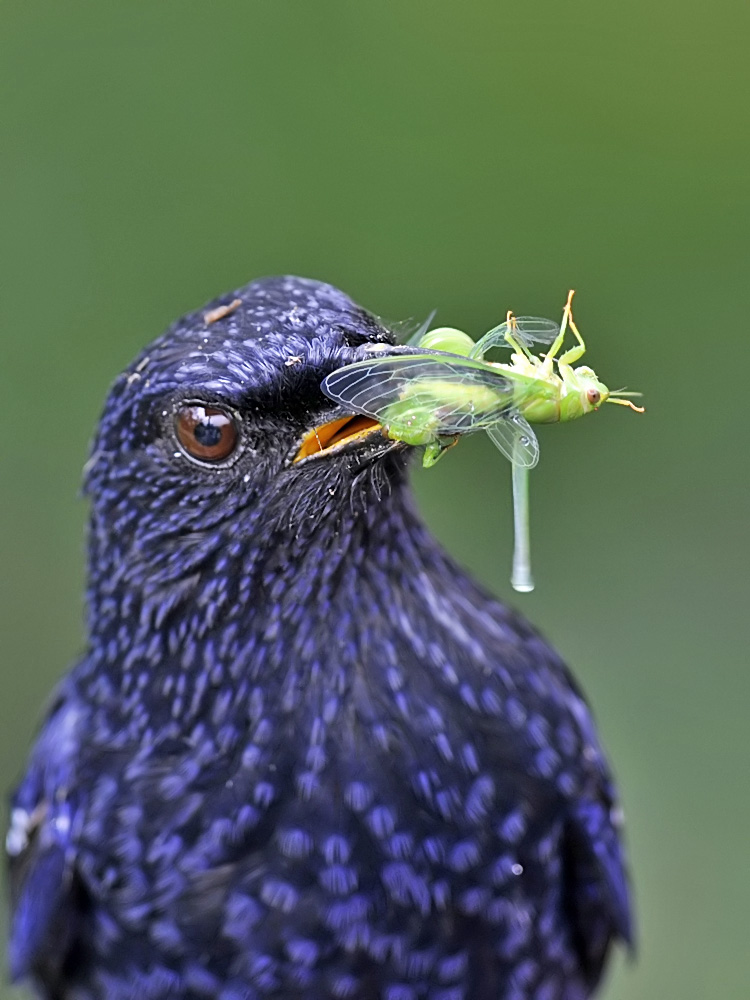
[{"x1": 6, "y1": 276, "x2": 633, "y2": 1000}]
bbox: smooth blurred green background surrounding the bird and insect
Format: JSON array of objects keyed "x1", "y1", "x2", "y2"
[{"x1": 0, "y1": 0, "x2": 750, "y2": 1000}]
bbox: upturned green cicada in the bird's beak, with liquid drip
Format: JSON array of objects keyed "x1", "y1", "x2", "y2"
[{"x1": 322, "y1": 291, "x2": 642, "y2": 591}]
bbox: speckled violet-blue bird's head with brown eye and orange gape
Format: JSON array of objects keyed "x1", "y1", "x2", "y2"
[{"x1": 86, "y1": 277, "x2": 414, "y2": 616}]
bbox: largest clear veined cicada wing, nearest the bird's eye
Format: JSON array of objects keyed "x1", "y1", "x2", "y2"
[{"x1": 321, "y1": 350, "x2": 533, "y2": 435}]
